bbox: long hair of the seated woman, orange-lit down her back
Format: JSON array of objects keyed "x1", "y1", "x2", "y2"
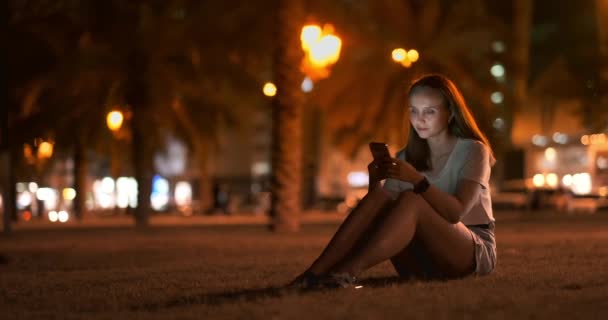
[{"x1": 405, "y1": 74, "x2": 496, "y2": 171}]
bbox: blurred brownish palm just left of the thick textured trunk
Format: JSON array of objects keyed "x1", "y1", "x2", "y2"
[{"x1": 138, "y1": 1, "x2": 271, "y2": 215}]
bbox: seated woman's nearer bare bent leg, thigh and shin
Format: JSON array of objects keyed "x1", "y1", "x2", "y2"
[{"x1": 332, "y1": 192, "x2": 475, "y2": 276}]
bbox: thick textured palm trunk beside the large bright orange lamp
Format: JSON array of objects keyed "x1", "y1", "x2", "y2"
[{"x1": 270, "y1": 0, "x2": 303, "y2": 232}]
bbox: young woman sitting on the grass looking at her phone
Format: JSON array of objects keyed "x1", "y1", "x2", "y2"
[{"x1": 289, "y1": 75, "x2": 496, "y2": 289}]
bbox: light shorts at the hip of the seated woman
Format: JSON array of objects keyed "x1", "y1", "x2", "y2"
[{"x1": 467, "y1": 222, "x2": 496, "y2": 276}]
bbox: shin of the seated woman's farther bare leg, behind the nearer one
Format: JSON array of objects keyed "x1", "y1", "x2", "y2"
[{"x1": 308, "y1": 187, "x2": 391, "y2": 274}]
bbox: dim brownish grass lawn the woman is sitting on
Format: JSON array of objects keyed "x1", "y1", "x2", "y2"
[{"x1": 0, "y1": 212, "x2": 608, "y2": 319}]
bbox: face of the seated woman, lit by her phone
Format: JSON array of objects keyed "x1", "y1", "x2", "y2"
[{"x1": 409, "y1": 87, "x2": 451, "y2": 139}]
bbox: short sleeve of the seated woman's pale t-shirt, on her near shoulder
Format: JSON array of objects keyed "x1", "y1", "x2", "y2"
[{"x1": 460, "y1": 141, "x2": 491, "y2": 189}]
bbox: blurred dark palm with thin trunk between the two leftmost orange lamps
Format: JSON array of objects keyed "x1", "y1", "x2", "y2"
[{"x1": 10, "y1": 33, "x2": 125, "y2": 219}]
